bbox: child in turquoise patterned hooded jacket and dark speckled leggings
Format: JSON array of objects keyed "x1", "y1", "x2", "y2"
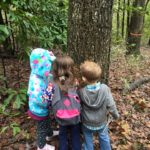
[{"x1": 28, "y1": 48, "x2": 55, "y2": 150}]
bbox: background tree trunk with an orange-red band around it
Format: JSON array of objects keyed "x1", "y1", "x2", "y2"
[{"x1": 127, "y1": 0, "x2": 146, "y2": 55}]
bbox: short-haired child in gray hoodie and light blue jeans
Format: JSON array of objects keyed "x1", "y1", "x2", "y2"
[{"x1": 79, "y1": 61, "x2": 119, "y2": 150}]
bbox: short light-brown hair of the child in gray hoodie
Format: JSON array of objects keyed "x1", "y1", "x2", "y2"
[{"x1": 80, "y1": 61, "x2": 102, "y2": 83}]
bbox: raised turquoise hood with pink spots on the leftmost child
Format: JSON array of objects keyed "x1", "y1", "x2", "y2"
[{"x1": 30, "y1": 48, "x2": 56, "y2": 78}]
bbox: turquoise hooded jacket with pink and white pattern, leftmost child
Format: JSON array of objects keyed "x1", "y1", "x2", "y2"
[{"x1": 27, "y1": 48, "x2": 55, "y2": 120}]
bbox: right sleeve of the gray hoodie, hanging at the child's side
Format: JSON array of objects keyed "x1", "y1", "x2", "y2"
[{"x1": 107, "y1": 87, "x2": 119, "y2": 119}]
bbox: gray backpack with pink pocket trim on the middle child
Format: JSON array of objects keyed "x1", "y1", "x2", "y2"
[{"x1": 52, "y1": 85, "x2": 80, "y2": 125}]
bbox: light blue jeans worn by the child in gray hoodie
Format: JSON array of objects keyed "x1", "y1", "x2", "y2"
[{"x1": 82, "y1": 125, "x2": 111, "y2": 150}]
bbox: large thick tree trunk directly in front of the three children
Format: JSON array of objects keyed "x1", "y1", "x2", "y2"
[{"x1": 68, "y1": 0, "x2": 113, "y2": 83}]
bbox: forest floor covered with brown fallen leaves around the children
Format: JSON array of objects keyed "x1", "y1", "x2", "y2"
[{"x1": 0, "y1": 47, "x2": 150, "y2": 150}]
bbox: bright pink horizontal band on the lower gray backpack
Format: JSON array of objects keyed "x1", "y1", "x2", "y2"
[{"x1": 56, "y1": 109, "x2": 80, "y2": 119}]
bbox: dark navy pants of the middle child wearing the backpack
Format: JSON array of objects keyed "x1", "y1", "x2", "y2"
[{"x1": 59, "y1": 124, "x2": 81, "y2": 150}]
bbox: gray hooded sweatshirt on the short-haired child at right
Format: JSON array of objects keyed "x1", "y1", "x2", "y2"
[{"x1": 79, "y1": 84, "x2": 119, "y2": 127}]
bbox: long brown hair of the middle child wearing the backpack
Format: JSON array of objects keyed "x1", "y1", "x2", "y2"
[{"x1": 53, "y1": 55, "x2": 74, "y2": 92}]
